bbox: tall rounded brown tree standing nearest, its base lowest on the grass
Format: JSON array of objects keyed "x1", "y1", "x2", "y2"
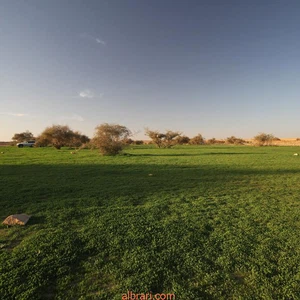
[{"x1": 93, "y1": 123, "x2": 131, "y2": 155}]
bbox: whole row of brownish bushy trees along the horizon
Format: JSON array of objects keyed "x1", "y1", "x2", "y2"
[{"x1": 12, "y1": 123, "x2": 279, "y2": 155}]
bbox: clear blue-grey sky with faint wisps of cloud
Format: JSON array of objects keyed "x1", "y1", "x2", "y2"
[{"x1": 0, "y1": 0, "x2": 300, "y2": 141}]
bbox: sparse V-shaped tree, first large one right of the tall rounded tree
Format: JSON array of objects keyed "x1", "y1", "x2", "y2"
[{"x1": 145, "y1": 128, "x2": 181, "y2": 148}]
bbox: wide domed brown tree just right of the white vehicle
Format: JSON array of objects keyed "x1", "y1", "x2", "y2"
[{"x1": 36, "y1": 125, "x2": 89, "y2": 149}]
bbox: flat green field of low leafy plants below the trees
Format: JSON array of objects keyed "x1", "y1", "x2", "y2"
[{"x1": 0, "y1": 146, "x2": 300, "y2": 300}]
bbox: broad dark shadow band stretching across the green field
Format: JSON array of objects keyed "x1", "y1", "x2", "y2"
[{"x1": 0, "y1": 163, "x2": 299, "y2": 217}]
